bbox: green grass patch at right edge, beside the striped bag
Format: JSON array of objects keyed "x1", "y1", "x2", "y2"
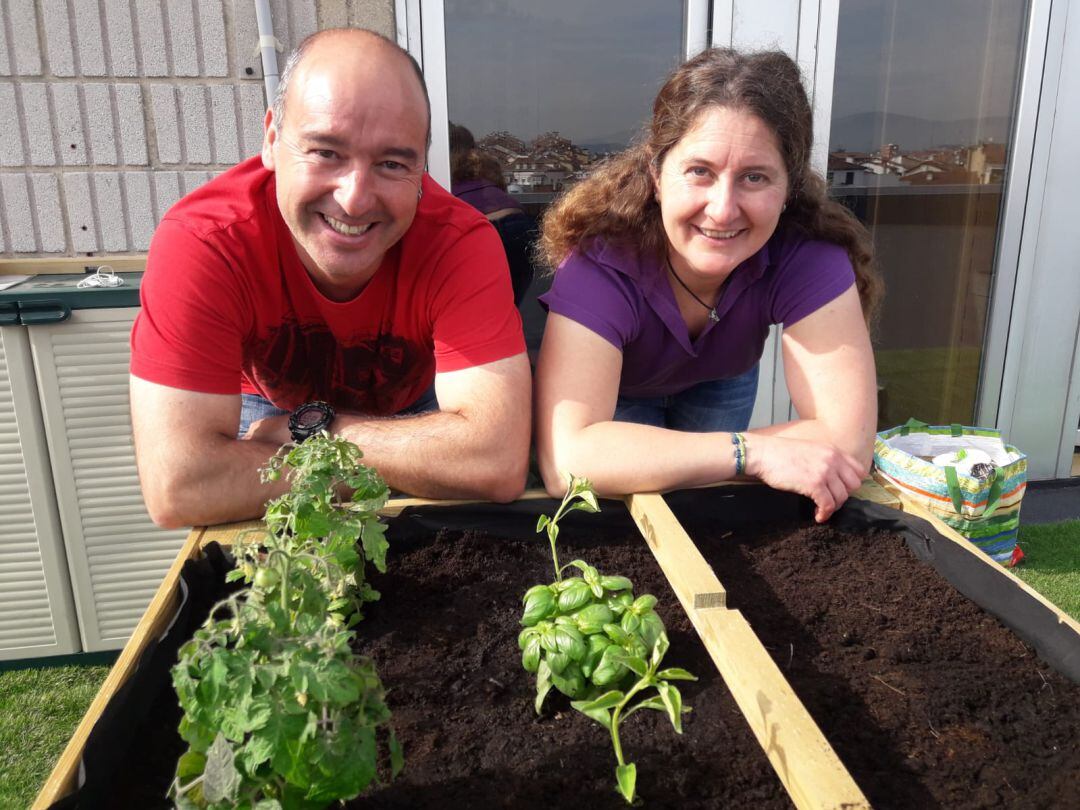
[{"x1": 1013, "y1": 521, "x2": 1080, "y2": 621}]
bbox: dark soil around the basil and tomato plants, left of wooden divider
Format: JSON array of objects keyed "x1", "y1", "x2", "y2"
[{"x1": 350, "y1": 522, "x2": 792, "y2": 810}]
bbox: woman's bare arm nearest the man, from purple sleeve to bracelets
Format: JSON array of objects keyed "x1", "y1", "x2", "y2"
[{"x1": 535, "y1": 312, "x2": 734, "y2": 497}]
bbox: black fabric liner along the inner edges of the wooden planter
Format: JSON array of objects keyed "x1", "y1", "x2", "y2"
[{"x1": 52, "y1": 486, "x2": 1080, "y2": 810}]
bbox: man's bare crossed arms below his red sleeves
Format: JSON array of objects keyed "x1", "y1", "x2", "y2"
[{"x1": 131, "y1": 353, "x2": 531, "y2": 527}]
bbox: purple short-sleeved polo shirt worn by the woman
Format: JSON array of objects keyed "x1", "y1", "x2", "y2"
[{"x1": 540, "y1": 231, "x2": 855, "y2": 396}]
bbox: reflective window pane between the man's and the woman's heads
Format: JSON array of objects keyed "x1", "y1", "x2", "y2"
[{"x1": 444, "y1": 0, "x2": 683, "y2": 352}]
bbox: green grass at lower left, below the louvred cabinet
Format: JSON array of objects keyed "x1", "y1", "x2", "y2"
[{"x1": 0, "y1": 665, "x2": 109, "y2": 809}]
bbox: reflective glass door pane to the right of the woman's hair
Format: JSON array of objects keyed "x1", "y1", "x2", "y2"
[{"x1": 827, "y1": 0, "x2": 1027, "y2": 427}]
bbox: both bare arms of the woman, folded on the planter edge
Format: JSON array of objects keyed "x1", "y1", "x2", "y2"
[{"x1": 535, "y1": 291, "x2": 875, "y2": 521}]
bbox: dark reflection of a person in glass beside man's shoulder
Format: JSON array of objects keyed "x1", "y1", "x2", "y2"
[{"x1": 450, "y1": 122, "x2": 539, "y2": 306}]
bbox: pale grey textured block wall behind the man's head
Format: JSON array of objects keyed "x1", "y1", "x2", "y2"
[{"x1": 0, "y1": 0, "x2": 394, "y2": 258}]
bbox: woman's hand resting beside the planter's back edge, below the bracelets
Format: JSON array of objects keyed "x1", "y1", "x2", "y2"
[{"x1": 746, "y1": 433, "x2": 866, "y2": 523}]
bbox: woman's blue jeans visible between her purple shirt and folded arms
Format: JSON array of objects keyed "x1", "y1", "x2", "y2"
[{"x1": 615, "y1": 364, "x2": 758, "y2": 433}]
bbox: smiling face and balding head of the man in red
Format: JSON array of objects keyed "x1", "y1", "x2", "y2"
[{"x1": 262, "y1": 32, "x2": 428, "y2": 300}]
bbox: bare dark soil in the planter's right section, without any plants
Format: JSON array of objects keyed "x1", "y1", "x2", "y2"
[{"x1": 691, "y1": 525, "x2": 1080, "y2": 810}]
